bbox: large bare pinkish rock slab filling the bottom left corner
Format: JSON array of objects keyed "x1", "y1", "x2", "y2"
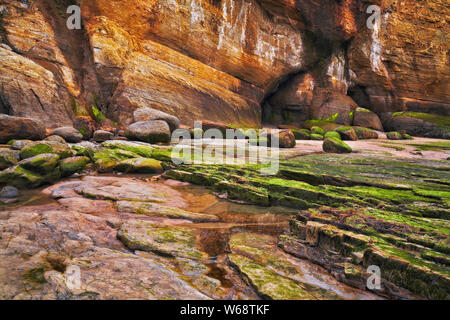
[{"x1": 0, "y1": 198, "x2": 207, "y2": 300}]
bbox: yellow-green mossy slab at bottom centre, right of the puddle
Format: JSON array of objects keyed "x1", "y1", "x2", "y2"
[{"x1": 229, "y1": 233, "x2": 377, "y2": 300}]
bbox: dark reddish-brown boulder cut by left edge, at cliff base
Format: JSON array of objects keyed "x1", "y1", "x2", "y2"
[{"x1": 0, "y1": 114, "x2": 45, "y2": 143}]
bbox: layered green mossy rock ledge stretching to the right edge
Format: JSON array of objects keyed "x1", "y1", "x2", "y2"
[{"x1": 164, "y1": 154, "x2": 450, "y2": 299}]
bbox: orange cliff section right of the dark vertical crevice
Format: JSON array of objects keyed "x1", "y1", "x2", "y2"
[{"x1": 348, "y1": 0, "x2": 450, "y2": 115}]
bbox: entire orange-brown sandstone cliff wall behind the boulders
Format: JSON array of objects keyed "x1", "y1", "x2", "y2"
[{"x1": 0, "y1": 0, "x2": 450, "y2": 131}]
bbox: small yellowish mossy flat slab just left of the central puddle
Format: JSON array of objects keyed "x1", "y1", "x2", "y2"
[{"x1": 117, "y1": 220, "x2": 209, "y2": 260}]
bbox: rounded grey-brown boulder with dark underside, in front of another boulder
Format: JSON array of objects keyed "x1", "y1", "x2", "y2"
[{"x1": 125, "y1": 120, "x2": 171, "y2": 143}]
